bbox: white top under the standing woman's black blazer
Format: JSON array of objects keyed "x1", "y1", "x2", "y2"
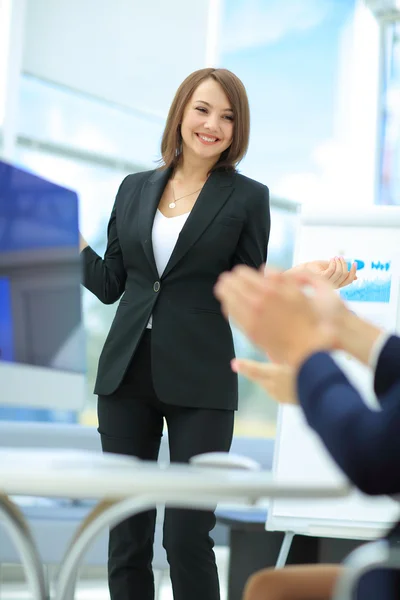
[{"x1": 147, "y1": 209, "x2": 190, "y2": 329}]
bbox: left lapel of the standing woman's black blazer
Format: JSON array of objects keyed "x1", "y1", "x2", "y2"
[{"x1": 139, "y1": 169, "x2": 172, "y2": 278}]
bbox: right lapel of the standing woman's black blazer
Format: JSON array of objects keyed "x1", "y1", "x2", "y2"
[{"x1": 162, "y1": 171, "x2": 234, "y2": 277}]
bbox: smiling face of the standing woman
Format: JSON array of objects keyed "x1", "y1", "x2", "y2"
[{"x1": 181, "y1": 79, "x2": 234, "y2": 162}]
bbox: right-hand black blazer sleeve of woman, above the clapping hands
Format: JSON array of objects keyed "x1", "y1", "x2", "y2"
[{"x1": 232, "y1": 185, "x2": 271, "y2": 269}]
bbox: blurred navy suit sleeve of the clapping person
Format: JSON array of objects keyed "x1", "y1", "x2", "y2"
[{"x1": 297, "y1": 353, "x2": 400, "y2": 495}]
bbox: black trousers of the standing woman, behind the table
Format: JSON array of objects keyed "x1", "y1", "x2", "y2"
[{"x1": 98, "y1": 332, "x2": 234, "y2": 600}]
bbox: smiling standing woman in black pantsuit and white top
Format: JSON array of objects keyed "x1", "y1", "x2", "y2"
[{"x1": 81, "y1": 69, "x2": 355, "y2": 600}]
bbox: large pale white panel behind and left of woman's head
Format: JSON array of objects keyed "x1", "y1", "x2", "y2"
[{"x1": 23, "y1": 0, "x2": 215, "y2": 114}]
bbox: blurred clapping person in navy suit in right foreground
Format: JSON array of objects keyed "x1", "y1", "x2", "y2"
[{"x1": 216, "y1": 269, "x2": 400, "y2": 600}]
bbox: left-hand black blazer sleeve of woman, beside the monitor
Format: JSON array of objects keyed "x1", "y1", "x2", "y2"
[{"x1": 81, "y1": 175, "x2": 129, "y2": 304}]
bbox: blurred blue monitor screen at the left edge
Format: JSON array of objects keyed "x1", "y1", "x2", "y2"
[{"x1": 0, "y1": 161, "x2": 86, "y2": 422}]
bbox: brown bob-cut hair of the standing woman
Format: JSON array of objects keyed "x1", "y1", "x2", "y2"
[{"x1": 160, "y1": 68, "x2": 250, "y2": 171}]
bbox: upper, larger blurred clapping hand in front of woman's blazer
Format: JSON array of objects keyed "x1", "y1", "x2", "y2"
[{"x1": 215, "y1": 266, "x2": 336, "y2": 367}]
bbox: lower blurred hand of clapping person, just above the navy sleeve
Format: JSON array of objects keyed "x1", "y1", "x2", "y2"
[{"x1": 231, "y1": 358, "x2": 297, "y2": 404}]
